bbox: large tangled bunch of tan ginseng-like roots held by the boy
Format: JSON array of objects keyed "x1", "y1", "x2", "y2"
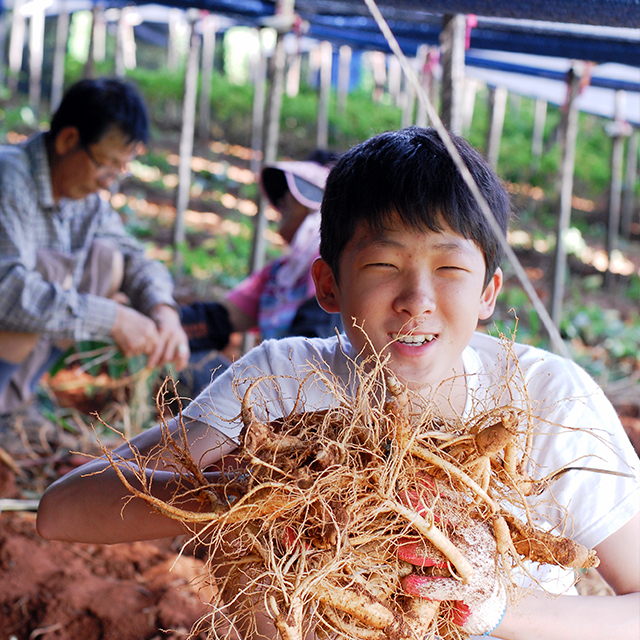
[{"x1": 105, "y1": 342, "x2": 598, "y2": 640}]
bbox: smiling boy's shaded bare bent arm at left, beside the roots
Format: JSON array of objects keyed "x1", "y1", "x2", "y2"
[{"x1": 37, "y1": 420, "x2": 236, "y2": 544}]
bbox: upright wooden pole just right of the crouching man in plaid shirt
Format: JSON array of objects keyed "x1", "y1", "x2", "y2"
[{"x1": 173, "y1": 19, "x2": 200, "y2": 278}]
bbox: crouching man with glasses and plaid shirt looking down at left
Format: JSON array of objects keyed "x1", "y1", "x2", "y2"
[{"x1": 0, "y1": 79, "x2": 189, "y2": 424}]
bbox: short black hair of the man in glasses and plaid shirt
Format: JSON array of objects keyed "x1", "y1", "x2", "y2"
[{"x1": 47, "y1": 78, "x2": 149, "y2": 147}]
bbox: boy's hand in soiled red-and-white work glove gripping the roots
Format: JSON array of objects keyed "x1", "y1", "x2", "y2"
[{"x1": 398, "y1": 479, "x2": 507, "y2": 635}]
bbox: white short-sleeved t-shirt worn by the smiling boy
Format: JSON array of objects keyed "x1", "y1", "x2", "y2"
[{"x1": 186, "y1": 333, "x2": 640, "y2": 593}]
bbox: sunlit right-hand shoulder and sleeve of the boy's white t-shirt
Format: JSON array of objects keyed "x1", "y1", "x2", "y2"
[{"x1": 470, "y1": 334, "x2": 640, "y2": 548}]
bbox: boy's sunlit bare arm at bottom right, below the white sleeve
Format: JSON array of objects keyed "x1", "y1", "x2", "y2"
[{"x1": 492, "y1": 514, "x2": 640, "y2": 640}]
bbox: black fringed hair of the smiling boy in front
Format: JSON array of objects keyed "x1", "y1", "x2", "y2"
[{"x1": 320, "y1": 127, "x2": 511, "y2": 286}]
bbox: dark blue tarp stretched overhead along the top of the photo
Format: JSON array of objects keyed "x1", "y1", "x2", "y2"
[{"x1": 5, "y1": 0, "x2": 640, "y2": 67}]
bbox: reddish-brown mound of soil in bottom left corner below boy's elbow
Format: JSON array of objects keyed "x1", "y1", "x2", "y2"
[{"x1": 0, "y1": 512, "x2": 209, "y2": 640}]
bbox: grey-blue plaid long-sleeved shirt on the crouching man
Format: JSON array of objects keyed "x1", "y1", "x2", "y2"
[{"x1": 0, "y1": 134, "x2": 176, "y2": 341}]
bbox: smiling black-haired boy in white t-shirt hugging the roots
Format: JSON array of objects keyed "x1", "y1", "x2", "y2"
[{"x1": 38, "y1": 127, "x2": 640, "y2": 640}]
